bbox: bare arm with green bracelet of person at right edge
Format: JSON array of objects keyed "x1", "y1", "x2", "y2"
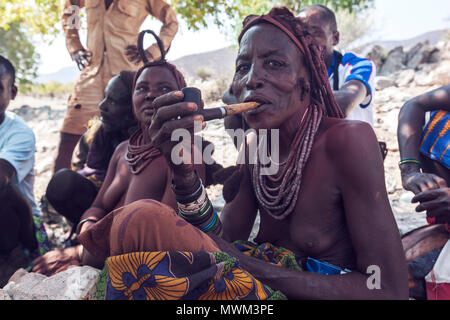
[{"x1": 397, "y1": 85, "x2": 450, "y2": 194}]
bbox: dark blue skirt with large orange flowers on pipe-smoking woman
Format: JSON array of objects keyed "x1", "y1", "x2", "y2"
[{"x1": 92, "y1": 242, "x2": 301, "y2": 300}]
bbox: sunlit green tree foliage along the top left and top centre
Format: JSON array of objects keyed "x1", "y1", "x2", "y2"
[{"x1": 0, "y1": 0, "x2": 374, "y2": 83}]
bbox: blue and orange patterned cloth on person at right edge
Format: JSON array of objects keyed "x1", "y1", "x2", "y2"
[{"x1": 420, "y1": 110, "x2": 450, "y2": 169}]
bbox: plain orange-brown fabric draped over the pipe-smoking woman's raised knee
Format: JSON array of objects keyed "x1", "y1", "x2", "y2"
[{"x1": 79, "y1": 199, "x2": 220, "y2": 259}]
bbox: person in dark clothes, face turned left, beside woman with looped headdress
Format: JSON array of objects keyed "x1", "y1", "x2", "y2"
[{"x1": 45, "y1": 71, "x2": 137, "y2": 239}]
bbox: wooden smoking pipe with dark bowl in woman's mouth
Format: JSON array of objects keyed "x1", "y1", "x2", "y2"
[{"x1": 181, "y1": 87, "x2": 259, "y2": 121}]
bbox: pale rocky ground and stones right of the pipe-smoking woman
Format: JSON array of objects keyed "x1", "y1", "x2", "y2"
[{"x1": 369, "y1": 41, "x2": 450, "y2": 234}]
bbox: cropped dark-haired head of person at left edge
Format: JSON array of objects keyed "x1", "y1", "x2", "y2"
[{"x1": 0, "y1": 55, "x2": 17, "y2": 115}]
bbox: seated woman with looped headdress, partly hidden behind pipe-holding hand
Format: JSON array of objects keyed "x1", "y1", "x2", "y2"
[{"x1": 33, "y1": 32, "x2": 205, "y2": 275}]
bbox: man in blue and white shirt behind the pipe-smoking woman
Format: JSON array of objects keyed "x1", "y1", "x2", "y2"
[{"x1": 222, "y1": 4, "x2": 376, "y2": 135}]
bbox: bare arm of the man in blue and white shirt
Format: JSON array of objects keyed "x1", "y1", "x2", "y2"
[{"x1": 333, "y1": 79, "x2": 370, "y2": 117}]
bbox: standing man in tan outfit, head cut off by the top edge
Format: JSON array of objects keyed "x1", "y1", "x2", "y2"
[{"x1": 53, "y1": 0, "x2": 178, "y2": 172}]
